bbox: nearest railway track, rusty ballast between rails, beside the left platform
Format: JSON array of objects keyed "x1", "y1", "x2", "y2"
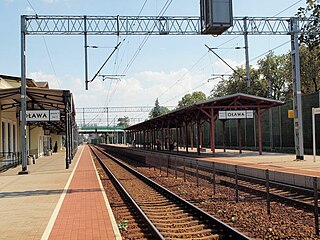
[{"x1": 91, "y1": 147, "x2": 250, "y2": 239}]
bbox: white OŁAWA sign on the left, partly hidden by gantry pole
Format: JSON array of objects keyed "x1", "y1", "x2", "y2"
[{"x1": 20, "y1": 110, "x2": 60, "y2": 122}]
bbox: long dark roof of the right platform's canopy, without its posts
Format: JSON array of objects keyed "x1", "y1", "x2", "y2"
[{"x1": 125, "y1": 93, "x2": 284, "y2": 130}]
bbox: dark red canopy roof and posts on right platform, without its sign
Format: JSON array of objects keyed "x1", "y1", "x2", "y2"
[{"x1": 125, "y1": 93, "x2": 284, "y2": 157}]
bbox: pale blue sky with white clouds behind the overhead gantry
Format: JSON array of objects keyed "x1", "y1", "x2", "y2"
[{"x1": 0, "y1": 0, "x2": 305, "y2": 125}]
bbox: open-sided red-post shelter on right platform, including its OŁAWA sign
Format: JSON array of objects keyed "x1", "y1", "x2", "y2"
[{"x1": 125, "y1": 93, "x2": 284, "y2": 155}]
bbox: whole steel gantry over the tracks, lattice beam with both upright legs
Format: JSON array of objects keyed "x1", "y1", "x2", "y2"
[{"x1": 21, "y1": 15, "x2": 308, "y2": 171}]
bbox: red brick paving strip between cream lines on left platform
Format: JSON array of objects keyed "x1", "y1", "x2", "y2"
[{"x1": 49, "y1": 146, "x2": 115, "y2": 240}]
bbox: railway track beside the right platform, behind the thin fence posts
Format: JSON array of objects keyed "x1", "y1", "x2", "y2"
[{"x1": 101, "y1": 145, "x2": 319, "y2": 212}]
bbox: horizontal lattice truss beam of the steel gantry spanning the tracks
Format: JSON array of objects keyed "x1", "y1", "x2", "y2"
[{"x1": 24, "y1": 15, "x2": 307, "y2": 35}]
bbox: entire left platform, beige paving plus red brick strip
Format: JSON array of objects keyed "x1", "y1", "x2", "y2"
[{"x1": 0, "y1": 146, "x2": 121, "y2": 240}]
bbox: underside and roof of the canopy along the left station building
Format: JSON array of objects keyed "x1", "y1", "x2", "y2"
[{"x1": 0, "y1": 87, "x2": 75, "y2": 134}]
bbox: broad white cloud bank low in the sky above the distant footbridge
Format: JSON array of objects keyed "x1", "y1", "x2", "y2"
[{"x1": 29, "y1": 60, "x2": 245, "y2": 124}]
